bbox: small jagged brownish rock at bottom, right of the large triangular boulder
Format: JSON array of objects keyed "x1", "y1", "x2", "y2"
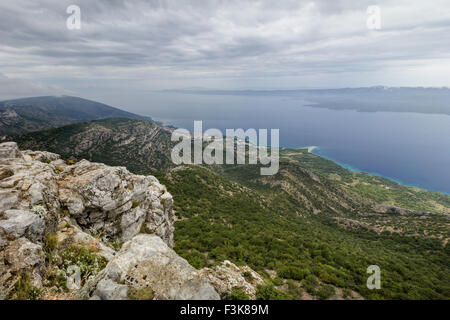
[{"x1": 201, "y1": 260, "x2": 264, "y2": 299}]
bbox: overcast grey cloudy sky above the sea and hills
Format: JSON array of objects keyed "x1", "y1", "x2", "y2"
[{"x1": 0, "y1": 0, "x2": 450, "y2": 102}]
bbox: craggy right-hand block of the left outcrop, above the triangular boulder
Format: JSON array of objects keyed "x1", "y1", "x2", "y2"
[{"x1": 58, "y1": 160, "x2": 174, "y2": 246}]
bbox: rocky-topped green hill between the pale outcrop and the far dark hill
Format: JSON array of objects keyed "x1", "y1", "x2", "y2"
[{"x1": 6, "y1": 118, "x2": 173, "y2": 174}]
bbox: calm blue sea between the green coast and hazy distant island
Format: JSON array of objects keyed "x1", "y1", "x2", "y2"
[{"x1": 136, "y1": 93, "x2": 450, "y2": 194}]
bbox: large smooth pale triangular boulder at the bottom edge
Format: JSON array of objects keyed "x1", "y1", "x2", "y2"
[{"x1": 86, "y1": 234, "x2": 220, "y2": 300}]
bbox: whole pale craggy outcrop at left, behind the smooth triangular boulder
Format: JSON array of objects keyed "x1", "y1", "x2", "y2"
[{"x1": 0, "y1": 142, "x2": 175, "y2": 298}]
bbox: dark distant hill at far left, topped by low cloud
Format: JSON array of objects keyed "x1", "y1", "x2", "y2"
[{"x1": 0, "y1": 96, "x2": 152, "y2": 135}]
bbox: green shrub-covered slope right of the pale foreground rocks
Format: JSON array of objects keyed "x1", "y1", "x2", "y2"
[{"x1": 158, "y1": 166, "x2": 450, "y2": 299}]
